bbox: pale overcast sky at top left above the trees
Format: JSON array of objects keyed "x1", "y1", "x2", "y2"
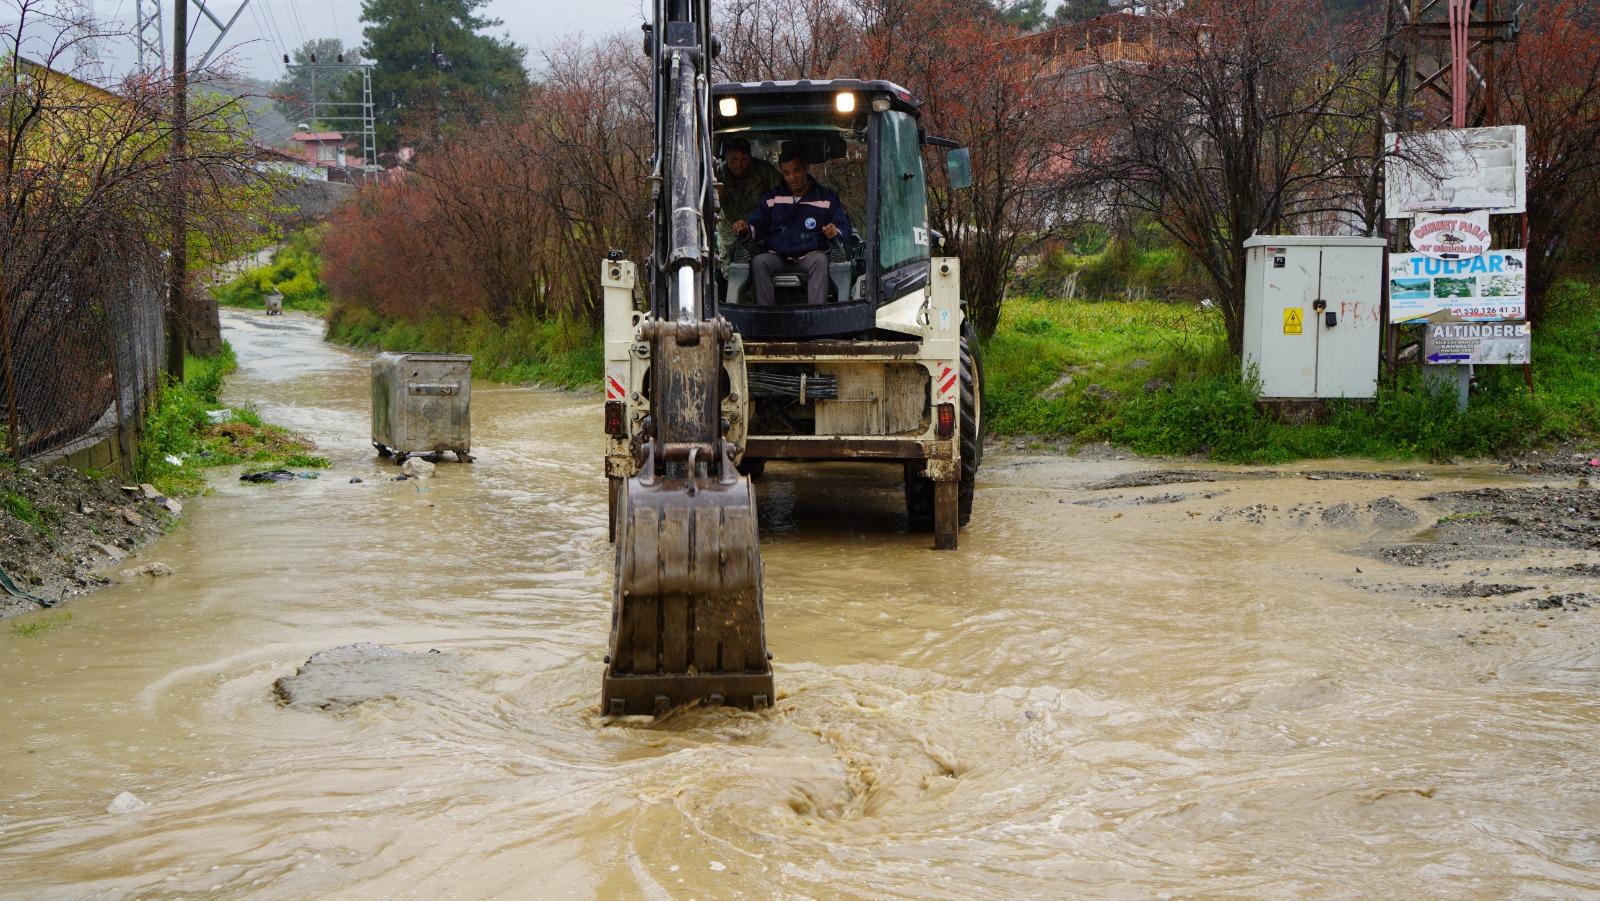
[{"x1": 0, "y1": 0, "x2": 643, "y2": 82}]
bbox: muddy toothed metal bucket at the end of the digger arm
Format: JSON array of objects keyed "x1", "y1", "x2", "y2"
[{"x1": 602, "y1": 467, "x2": 773, "y2": 717}]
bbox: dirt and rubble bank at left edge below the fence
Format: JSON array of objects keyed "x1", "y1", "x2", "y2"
[{"x1": 0, "y1": 464, "x2": 181, "y2": 619}]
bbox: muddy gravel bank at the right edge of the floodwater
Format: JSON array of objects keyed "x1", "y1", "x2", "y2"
[{"x1": 1075, "y1": 445, "x2": 1600, "y2": 611}]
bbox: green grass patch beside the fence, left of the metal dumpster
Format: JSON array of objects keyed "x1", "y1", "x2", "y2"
[{"x1": 136, "y1": 344, "x2": 328, "y2": 498}]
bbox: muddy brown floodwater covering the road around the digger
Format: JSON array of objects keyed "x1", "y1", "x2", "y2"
[{"x1": 0, "y1": 314, "x2": 1600, "y2": 898}]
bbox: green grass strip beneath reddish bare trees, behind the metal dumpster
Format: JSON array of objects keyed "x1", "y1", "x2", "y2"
[{"x1": 328, "y1": 307, "x2": 605, "y2": 387}]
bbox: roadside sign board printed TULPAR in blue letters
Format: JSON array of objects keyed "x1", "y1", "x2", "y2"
[{"x1": 1389, "y1": 250, "x2": 1528, "y2": 323}]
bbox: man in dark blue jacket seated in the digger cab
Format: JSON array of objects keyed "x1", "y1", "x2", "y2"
[{"x1": 733, "y1": 147, "x2": 850, "y2": 307}]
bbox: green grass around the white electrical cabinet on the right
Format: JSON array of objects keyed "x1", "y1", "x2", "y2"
[{"x1": 986, "y1": 283, "x2": 1600, "y2": 463}]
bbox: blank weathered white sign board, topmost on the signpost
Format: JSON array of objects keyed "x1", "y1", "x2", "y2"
[{"x1": 1384, "y1": 125, "x2": 1528, "y2": 219}]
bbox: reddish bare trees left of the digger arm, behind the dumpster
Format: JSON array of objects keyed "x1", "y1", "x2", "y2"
[{"x1": 323, "y1": 35, "x2": 650, "y2": 325}]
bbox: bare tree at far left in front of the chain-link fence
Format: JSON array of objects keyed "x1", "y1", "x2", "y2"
[{"x1": 0, "y1": 0, "x2": 268, "y2": 455}]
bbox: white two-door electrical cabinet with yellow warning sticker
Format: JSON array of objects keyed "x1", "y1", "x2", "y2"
[{"x1": 1245, "y1": 235, "x2": 1384, "y2": 400}]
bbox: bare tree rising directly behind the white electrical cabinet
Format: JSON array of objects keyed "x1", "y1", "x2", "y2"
[{"x1": 1066, "y1": 0, "x2": 1381, "y2": 349}]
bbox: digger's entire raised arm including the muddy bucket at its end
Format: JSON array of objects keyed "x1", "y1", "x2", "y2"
[{"x1": 602, "y1": 0, "x2": 773, "y2": 715}]
